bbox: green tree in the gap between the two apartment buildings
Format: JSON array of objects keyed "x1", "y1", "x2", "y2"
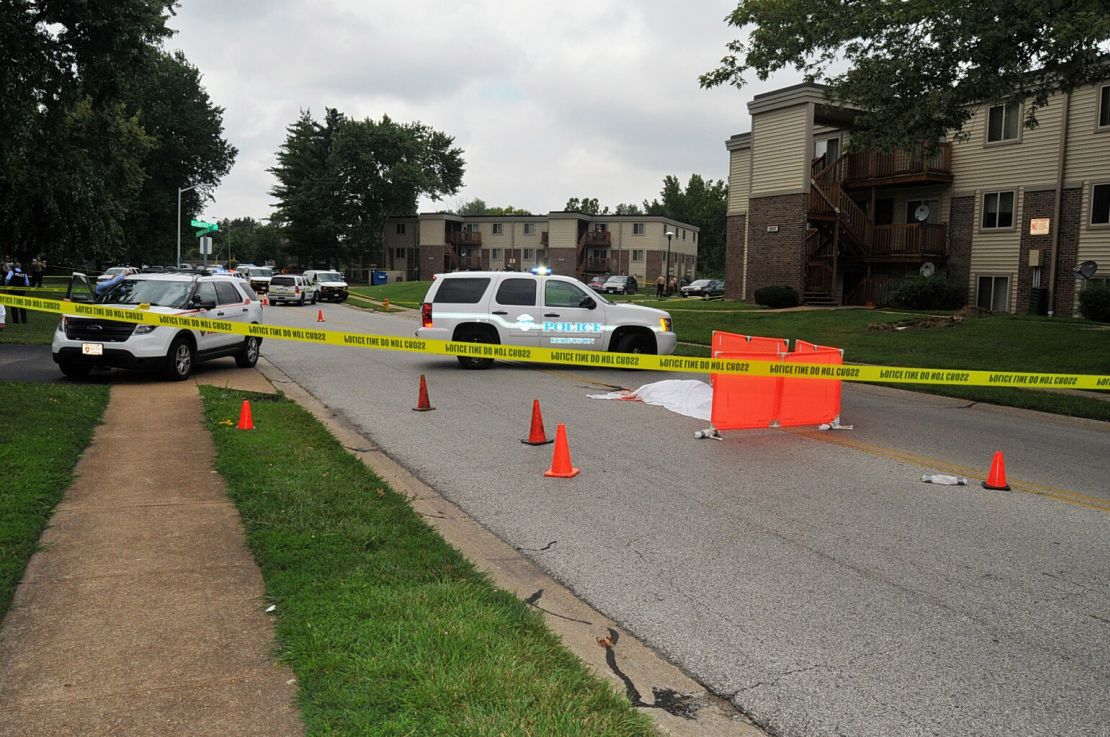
[{"x1": 644, "y1": 174, "x2": 728, "y2": 275}]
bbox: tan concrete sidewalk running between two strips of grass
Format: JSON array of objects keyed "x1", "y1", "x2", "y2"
[{"x1": 0, "y1": 370, "x2": 304, "y2": 737}]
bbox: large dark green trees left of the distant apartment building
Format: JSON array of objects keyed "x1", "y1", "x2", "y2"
[{"x1": 270, "y1": 109, "x2": 464, "y2": 265}]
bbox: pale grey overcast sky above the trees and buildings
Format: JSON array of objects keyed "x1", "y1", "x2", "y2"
[{"x1": 167, "y1": 0, "x2": 797, "y2": 218}]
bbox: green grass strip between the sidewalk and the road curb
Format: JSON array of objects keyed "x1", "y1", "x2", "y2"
[{"x1": 201, "y1": 387, "x2": 656, "y2": 737}]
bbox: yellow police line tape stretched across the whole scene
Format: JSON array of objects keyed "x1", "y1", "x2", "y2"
[{"x1": 0, "y1": 294, "x2": 1110, "y2": 391}]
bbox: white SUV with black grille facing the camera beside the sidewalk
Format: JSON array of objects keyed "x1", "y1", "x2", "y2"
[{"x1": 51, "y1": 273, "x2": 262, "y2": 381}]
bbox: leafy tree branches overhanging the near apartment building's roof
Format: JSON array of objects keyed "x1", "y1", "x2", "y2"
[{"x1": 699, "y1": 0, "x2": 1110, "y2": 150}]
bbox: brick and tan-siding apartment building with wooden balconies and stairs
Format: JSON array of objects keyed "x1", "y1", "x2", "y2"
[{"x1": 726, "y1": 80, "x2": 1110, "y2": 315}]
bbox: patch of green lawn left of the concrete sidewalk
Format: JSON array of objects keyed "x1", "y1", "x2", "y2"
[{"x1": 0, "y1": 383, "x2": 108, "y2": 618}]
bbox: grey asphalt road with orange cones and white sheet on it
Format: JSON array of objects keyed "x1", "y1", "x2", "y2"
[{"x1": 17, "y1": 305, "x2": 1110, "y2": 737}]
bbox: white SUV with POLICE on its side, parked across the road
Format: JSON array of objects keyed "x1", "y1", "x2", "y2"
[{"x1": 416, "y1": 271, "x2": 677, "y2": 369}]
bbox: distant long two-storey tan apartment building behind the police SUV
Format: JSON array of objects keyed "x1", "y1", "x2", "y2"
[{"x1": 385, "y1": 212, "x2": 698, "y2": 285}]
